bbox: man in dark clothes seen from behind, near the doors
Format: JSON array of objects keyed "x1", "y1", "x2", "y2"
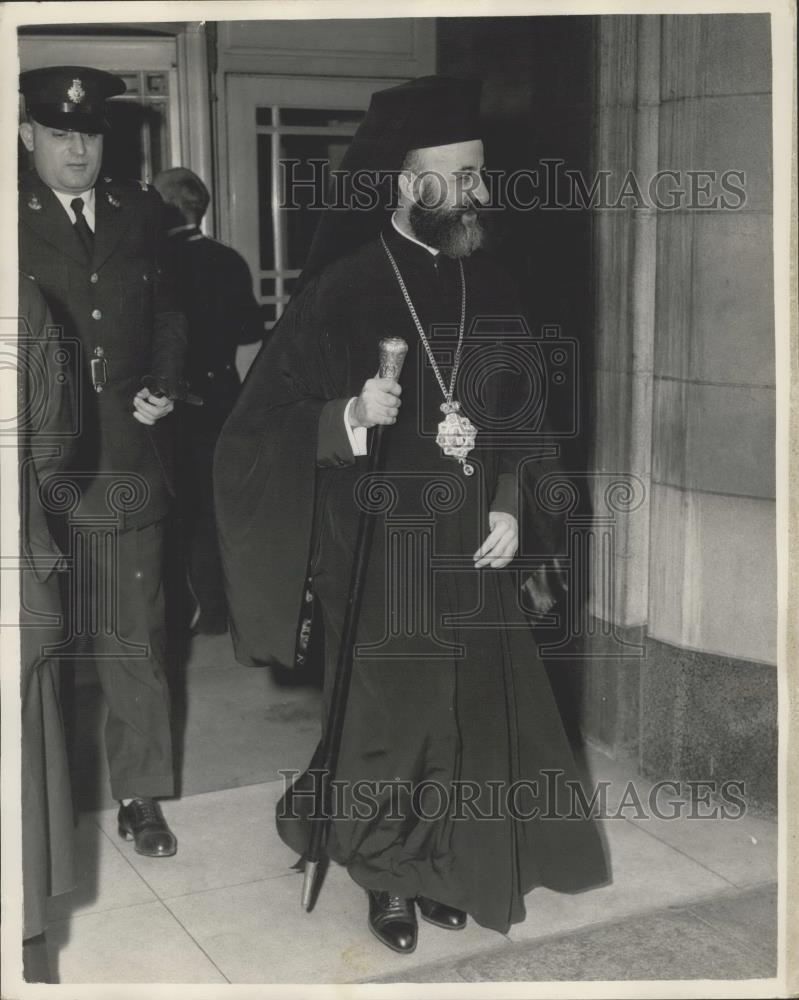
[{"x1": 153, "y1": 167, "x2": 263, "y2": 635}]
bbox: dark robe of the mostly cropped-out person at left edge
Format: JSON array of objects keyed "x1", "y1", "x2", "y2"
[{"x1": 18, "y1": 274, "x2": 76, "y2": 939}]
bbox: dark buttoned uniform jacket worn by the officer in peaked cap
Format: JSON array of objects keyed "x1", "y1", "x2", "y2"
[{"x1": 19, "y1": 170, "x2": 186, "y2": 527}]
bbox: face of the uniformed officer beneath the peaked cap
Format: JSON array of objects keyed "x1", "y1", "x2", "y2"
[{"x1": 19, "y1": 122, "x2": 103, "y2": 194}]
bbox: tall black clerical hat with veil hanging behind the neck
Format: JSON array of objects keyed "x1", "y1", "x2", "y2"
[{"x1": 300, "y1": 76, "x2": 482, "y2": 284}]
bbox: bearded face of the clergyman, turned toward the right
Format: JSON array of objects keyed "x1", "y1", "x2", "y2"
[{"x1": 408, "y1": 139, "x2": 488, "y2": 257}]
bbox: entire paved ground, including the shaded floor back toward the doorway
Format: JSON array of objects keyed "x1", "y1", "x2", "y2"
[{"x1": 39, "y1": 636, "x2": 777, "y2": 995}]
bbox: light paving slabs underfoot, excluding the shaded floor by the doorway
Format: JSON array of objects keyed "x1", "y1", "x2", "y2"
[{"x1": 42, "y1": 773, "x2": 776, "y2": 983}]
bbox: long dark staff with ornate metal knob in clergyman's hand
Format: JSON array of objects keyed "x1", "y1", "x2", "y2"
[{"x1": 302, "y1": 337, "x2": 408, "y2": 910}]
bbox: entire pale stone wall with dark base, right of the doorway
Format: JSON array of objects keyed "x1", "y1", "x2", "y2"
[{"x1": 588, "y1": 15, "x2": 777, "y2": 806}]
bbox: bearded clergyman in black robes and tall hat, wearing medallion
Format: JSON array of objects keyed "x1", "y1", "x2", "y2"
[{"x1": 215, "y1": 77, "x2": 607, "y2": 953}]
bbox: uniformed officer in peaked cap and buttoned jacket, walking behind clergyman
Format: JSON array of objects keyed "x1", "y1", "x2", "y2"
[{"x1": 19, "y1": 66, "x2": 186, "y2": 857}]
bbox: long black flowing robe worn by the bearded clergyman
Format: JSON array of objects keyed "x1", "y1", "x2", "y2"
[{"x1": 216, "y1": 229, "x2": 607, "y2": 931}]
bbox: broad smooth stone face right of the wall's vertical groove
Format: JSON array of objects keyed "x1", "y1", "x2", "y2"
[{"x1": 641, "y1": 15, "x2": 777, "y2": 804}]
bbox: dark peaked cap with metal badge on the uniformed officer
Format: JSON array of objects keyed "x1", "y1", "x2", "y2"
[{"x1": 19, "y1": 66, "x2": 125, "y2": 132}]
